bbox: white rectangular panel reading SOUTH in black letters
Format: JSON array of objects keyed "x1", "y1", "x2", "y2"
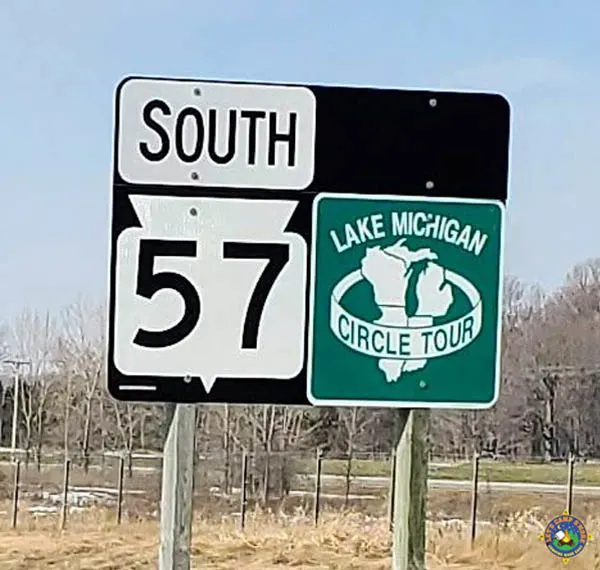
[{"x1": 117, "y1": 79, "x2": 316, "y2": 190}]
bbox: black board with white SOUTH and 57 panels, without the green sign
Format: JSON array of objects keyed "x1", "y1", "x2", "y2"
[{"x1": 108, "y1": 78, "x2": 509, "y2": 405}]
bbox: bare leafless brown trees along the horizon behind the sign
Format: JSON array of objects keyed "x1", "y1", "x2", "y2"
[{"x1": 0, "y1": 259, "x2": 600, "y2": 463}]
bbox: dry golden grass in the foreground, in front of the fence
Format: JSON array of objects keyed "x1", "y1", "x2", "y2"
[{"x1": 0, "y1": 504, "x2": 600, "y2": 570}]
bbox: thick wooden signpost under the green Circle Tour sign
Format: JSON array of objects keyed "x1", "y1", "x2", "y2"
[{"x1": 392, "y1": 409, "x2": 429, "y2": 570}]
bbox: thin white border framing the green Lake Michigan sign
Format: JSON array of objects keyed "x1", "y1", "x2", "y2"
[{"x1": 306, "y1": 192, "x2": 506, "y2": 410}]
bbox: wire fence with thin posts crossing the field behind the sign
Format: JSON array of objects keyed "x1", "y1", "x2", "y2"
[{"x1": 0, "y1": 451, "x2": 600, "y2": 537}]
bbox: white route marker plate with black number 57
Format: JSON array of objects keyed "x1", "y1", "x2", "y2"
[{"x1": 115, "y1": 196, "x2": 307, "y2": 392}]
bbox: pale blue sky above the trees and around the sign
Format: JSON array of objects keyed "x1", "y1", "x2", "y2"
[{"x1": 0, "y1": 0, "x2": 600, "y2": 321}]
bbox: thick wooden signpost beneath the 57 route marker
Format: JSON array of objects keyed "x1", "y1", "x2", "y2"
[{"x1": 158, "y1": 404, "x2": 196, "y2": 570}]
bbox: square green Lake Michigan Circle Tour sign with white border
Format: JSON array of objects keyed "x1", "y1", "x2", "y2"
[{"x1": 308, "y1": 194, "x2": 504, "y2": 408}]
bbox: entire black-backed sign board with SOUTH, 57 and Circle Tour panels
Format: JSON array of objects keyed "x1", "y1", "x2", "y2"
[{"x1": 107, "y1": 77, "x2": 509, "y2": 407}]
